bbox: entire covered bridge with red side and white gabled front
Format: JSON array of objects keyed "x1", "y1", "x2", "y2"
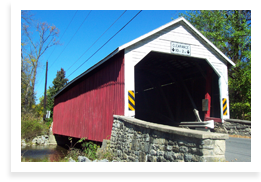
[{"x1": 53, "y1": 17, "x2": 235, "y2": 142}]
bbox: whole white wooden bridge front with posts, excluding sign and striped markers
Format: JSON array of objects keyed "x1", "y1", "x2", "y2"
[{"x1": 121, "y1": 17, "x2": 235, "y2": 120}]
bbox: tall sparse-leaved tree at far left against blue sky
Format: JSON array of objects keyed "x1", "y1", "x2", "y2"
[{"x1": 21, "y1": 11, "x2": 59, "y2": 112}]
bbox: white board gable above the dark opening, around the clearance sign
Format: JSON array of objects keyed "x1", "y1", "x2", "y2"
[{"x1": 125, "y1": 23, "x2": 227, "y2": 75}]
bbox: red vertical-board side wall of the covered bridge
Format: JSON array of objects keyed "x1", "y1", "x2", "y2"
[{"x1": 53, "y1": 51, "x2": 124, "y2": 142}]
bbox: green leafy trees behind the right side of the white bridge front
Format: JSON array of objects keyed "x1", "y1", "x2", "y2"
[{"x1": 180, "y1": 10, "x2": 251, "y2": 120}]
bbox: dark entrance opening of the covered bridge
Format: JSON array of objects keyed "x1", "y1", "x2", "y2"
[{"x1": 135, "y1": 52, "x2": 221, "y2": 126}]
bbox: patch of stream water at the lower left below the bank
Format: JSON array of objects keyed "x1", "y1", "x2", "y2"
[{"x1": 21, "y1": 145, "x2": 67, "y2": 162}]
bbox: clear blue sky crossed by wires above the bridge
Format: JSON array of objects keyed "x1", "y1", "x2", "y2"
[{"x1": 24, "y1": 10, "x2": 185, "y2": 103}]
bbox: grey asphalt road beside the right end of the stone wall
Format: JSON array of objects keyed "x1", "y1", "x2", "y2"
[{"x1": 225, "y1": 137, "x2": 251, "y2": 162}]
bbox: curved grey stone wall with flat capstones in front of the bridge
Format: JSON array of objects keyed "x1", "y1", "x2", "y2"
[{"x1": 110, "y1": 115, "x2": 228, "y2": 162}]
